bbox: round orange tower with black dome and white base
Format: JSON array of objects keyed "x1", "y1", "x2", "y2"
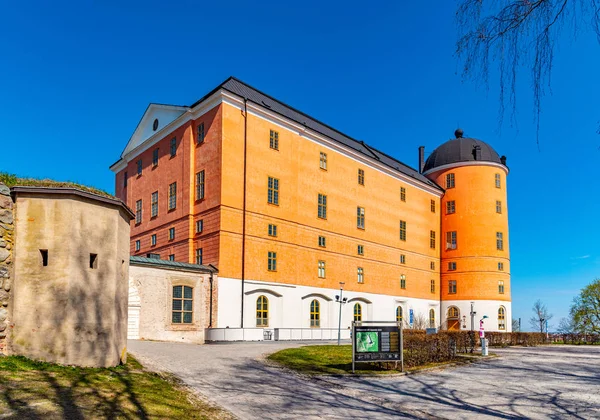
[{"x1": 423, "y1": 129, "x2": 512, "y2": 332}]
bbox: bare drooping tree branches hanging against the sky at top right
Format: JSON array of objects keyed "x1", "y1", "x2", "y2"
[{"x1": 456, "y1": 0, "x2": 600, "y2": 146}]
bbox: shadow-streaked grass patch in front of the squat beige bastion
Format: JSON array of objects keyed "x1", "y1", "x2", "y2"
[{"x1": 0, "y1": 355, "x2": 232, "y2": 419}]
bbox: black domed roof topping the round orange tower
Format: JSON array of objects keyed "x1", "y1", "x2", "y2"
[{"x1": 423, "y1": 129, "x2": 506, "y2": 172}]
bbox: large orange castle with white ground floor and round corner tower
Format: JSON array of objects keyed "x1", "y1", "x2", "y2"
[{"x1": 111, "y1": 78, "x2": 510, "y2": 336}]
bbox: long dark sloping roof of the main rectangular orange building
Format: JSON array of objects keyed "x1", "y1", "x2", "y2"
[{"x1": 190, "y1": 77, "x2": 441, "y2": 189}]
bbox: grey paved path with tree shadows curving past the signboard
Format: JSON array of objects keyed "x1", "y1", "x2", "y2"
[{"x1": 129, "y1": 341, "x2": 600, "y2": 419}]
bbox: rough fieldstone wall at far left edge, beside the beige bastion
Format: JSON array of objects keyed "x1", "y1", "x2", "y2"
[{"x1": 0, "y1": 182, "x2": 14, "y2": 354}]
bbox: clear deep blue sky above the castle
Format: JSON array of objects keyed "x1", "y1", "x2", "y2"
[{"x1": 0, "y1": 1, "x2": 600, "y2": 326}]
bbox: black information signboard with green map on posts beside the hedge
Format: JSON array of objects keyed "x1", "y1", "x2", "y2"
[{"x1": 352, "y1": 321, "x2": 404, "y2": 373}]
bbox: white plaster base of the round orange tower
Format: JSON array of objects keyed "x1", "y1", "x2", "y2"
[{"x1": 442, "y1": 300, "x2": 512, "y2": 332}]
